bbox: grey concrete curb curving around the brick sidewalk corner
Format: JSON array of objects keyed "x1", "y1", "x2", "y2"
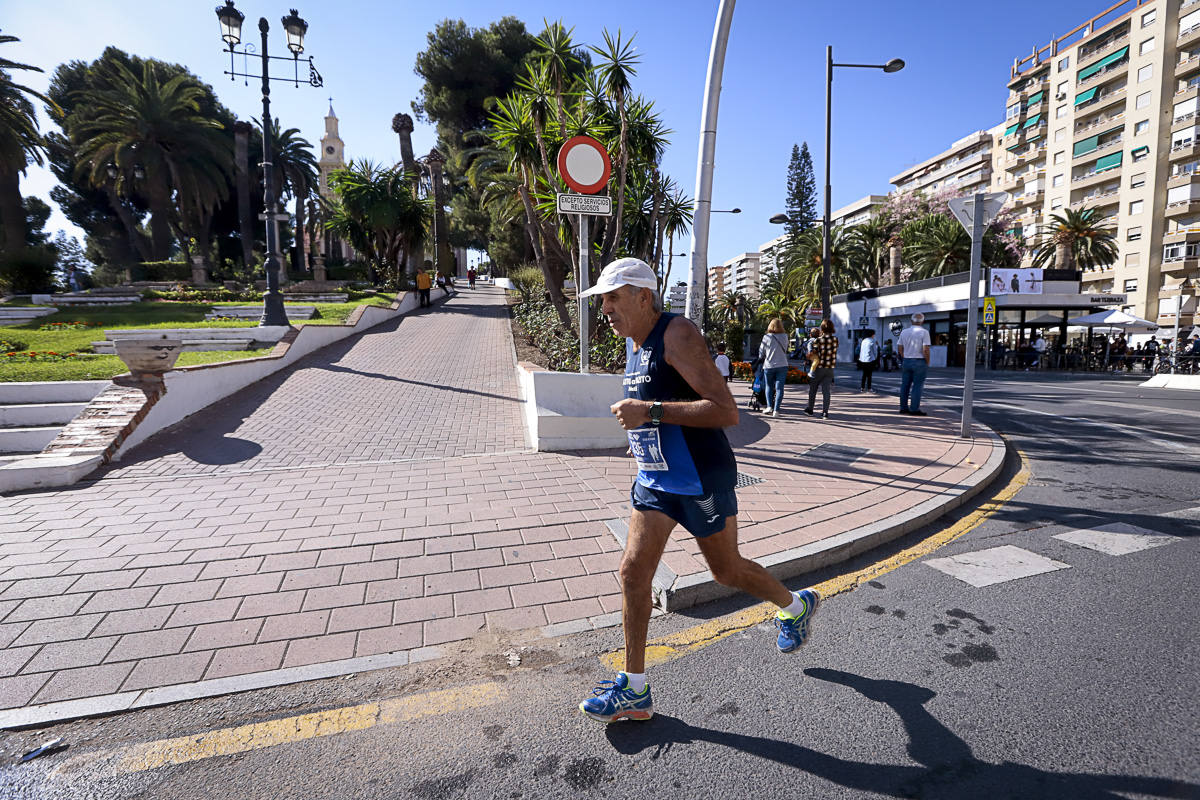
[{"x1": 648, "y1": 423, "x2": 1007, "y2": 612}]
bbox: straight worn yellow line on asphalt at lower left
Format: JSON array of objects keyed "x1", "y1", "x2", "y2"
[{"x1": 59, "y1": 682, "x2": 508, "y2": 774}]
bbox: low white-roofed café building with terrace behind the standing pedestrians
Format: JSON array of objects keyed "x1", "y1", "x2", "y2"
[{"x1": 832, "y1": 270, "x2": 1127, "y2": 367}]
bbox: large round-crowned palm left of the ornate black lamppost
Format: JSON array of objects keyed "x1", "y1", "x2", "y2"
[{"x1": 70, "y1": 61, "x2": 233, "y2": 259}]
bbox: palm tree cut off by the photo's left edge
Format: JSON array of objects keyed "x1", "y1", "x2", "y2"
[{"x1": 0, "y1": 35, "x2": 58, "y2": 257}]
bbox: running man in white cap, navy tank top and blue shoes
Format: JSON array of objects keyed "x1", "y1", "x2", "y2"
[{"x1": 580, "y1": 258, "x2": 821, "y2": 722}]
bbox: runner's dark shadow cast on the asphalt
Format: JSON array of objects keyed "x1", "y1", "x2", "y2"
[{"x1": 605, "y1": 668, "x2": 1200, "y2": 800}]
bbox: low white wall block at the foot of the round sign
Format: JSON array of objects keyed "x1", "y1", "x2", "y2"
[{"x1": 517, "y1": 363, "x2": 629, "y2": 452}]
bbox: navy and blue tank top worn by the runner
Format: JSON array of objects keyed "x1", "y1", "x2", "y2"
[{"x1": 624, "y1": 313, "x2": 737, "y2": 495}]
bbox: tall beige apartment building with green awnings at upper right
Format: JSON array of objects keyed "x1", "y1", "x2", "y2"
[{"x1": 995, "y1": 0, "x2": 1200, "y2": 326}]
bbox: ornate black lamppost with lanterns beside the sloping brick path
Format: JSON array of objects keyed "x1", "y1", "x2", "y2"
[{"x1": 217, "y1": 0, "x2": 325, "y2": 325}]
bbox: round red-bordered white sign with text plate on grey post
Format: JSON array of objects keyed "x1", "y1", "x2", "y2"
[{"x1": 557, "y1": 136, "x2": 612, "y2": 374}]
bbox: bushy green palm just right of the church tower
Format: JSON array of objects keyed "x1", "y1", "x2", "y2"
[{"x1": 325, "y1": 161, "x2": 432, "y2": 285}]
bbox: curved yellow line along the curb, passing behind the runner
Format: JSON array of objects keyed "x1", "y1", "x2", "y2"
[{"x1": 600, "y1": 450, "x2": 1030, "y2": 670}]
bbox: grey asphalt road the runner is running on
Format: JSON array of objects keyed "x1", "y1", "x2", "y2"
[{"x1": 0, "y1": 371, "x2": 1200, "y2": 800}]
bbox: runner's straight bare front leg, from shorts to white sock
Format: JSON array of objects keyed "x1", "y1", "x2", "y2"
[{"x1": 620, "y1": 509, "x2": 676, "y2": 674}]
